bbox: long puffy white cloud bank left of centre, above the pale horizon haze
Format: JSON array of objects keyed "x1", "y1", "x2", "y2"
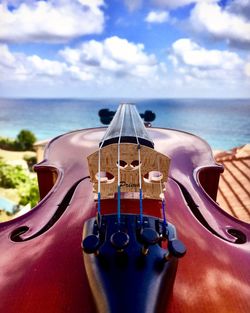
[{"x1": 0, "y1": 37, "x2": 166, "y2": 85}]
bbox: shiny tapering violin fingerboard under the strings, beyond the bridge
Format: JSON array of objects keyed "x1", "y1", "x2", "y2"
[{"x1": 100, "y1": 103, "x2": 154, "y2": 148}]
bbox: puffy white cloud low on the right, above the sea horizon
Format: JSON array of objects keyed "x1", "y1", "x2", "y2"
[{"x1": 169, "y1": 38, "x2": 247, "y2": 85}]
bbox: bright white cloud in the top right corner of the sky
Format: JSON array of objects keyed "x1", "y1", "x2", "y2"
[{"x1": 190, "y1": 2, "x2": 250, "y2": 44}]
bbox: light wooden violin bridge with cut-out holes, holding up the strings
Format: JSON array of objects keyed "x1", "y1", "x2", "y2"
[{"x1": 88, "y1": 143, "x2": 170, "y2": 199}]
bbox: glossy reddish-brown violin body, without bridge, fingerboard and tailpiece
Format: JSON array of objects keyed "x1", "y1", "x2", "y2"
[{"x1": 0, "y1": 120, "x2": 250, "y2": 313}]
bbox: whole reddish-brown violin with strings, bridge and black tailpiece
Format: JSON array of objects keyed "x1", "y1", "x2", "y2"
[{"x1": 0, "y1": 104, "x2": 250, "y2": 313}]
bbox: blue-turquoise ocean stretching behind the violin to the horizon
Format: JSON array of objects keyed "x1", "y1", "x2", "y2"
[{"x1": 0, "y1": 99, "x2": 250, "y2": 150}]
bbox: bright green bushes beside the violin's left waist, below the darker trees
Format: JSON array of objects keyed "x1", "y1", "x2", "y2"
[{"x1": 0, "y1": 159, "x2": 39, "y2": 207}]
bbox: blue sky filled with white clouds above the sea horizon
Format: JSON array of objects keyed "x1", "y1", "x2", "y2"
[{"x1": 0, "y1": 0, "x2": 250, "y2": 98}]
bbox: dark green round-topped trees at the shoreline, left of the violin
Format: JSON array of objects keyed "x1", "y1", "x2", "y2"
[{"x1": 0, "y1": 129, "x2": 36, "y2": 151}]
